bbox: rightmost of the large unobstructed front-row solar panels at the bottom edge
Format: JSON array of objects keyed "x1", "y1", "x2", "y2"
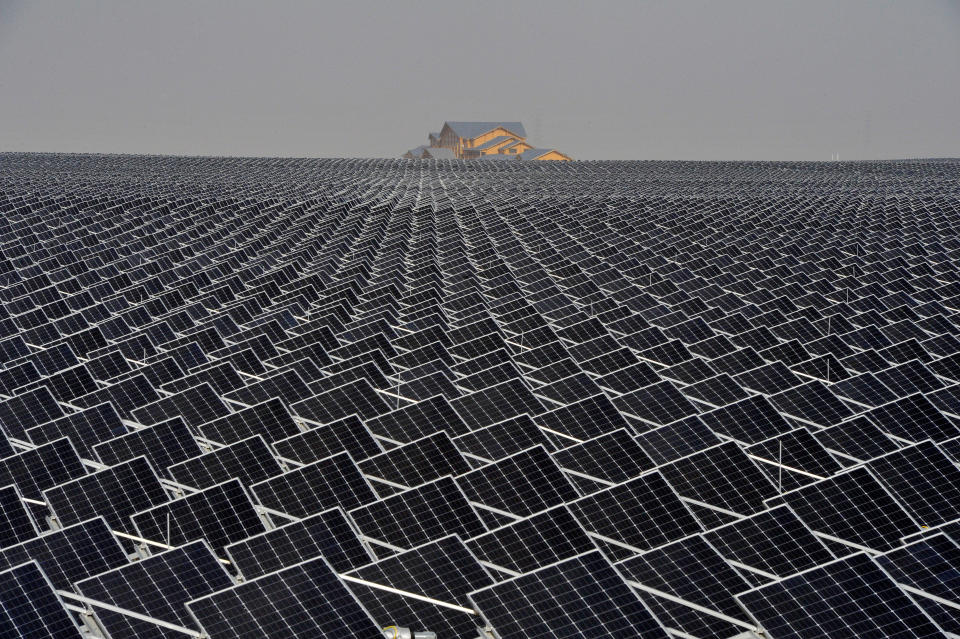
[{"x1": 737, "y1": 553, "x2": 943, "y2": 639}]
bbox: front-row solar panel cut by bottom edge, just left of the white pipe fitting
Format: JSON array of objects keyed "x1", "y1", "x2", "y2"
[{"x1": 187, "y1": 557, "x2": 381, "y2": 639}]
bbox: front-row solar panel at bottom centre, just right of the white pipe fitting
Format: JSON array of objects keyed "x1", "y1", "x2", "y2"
[{"x1": 470, "y1": 551, "x2": 668, "y2": 639}]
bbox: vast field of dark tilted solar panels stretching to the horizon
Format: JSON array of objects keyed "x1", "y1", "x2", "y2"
[{"x1": 0, "y1": 154, "x2": 960, "y2": 639}]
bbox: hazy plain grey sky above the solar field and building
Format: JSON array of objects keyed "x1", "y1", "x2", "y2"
[{"x1": 0, "y1": 0, "x2": 960, "y2": 160}]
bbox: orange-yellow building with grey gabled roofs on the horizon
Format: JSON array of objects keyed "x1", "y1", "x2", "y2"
[{"x1": 403, "y1": 121, "x2": 573, "y2": 162}]
